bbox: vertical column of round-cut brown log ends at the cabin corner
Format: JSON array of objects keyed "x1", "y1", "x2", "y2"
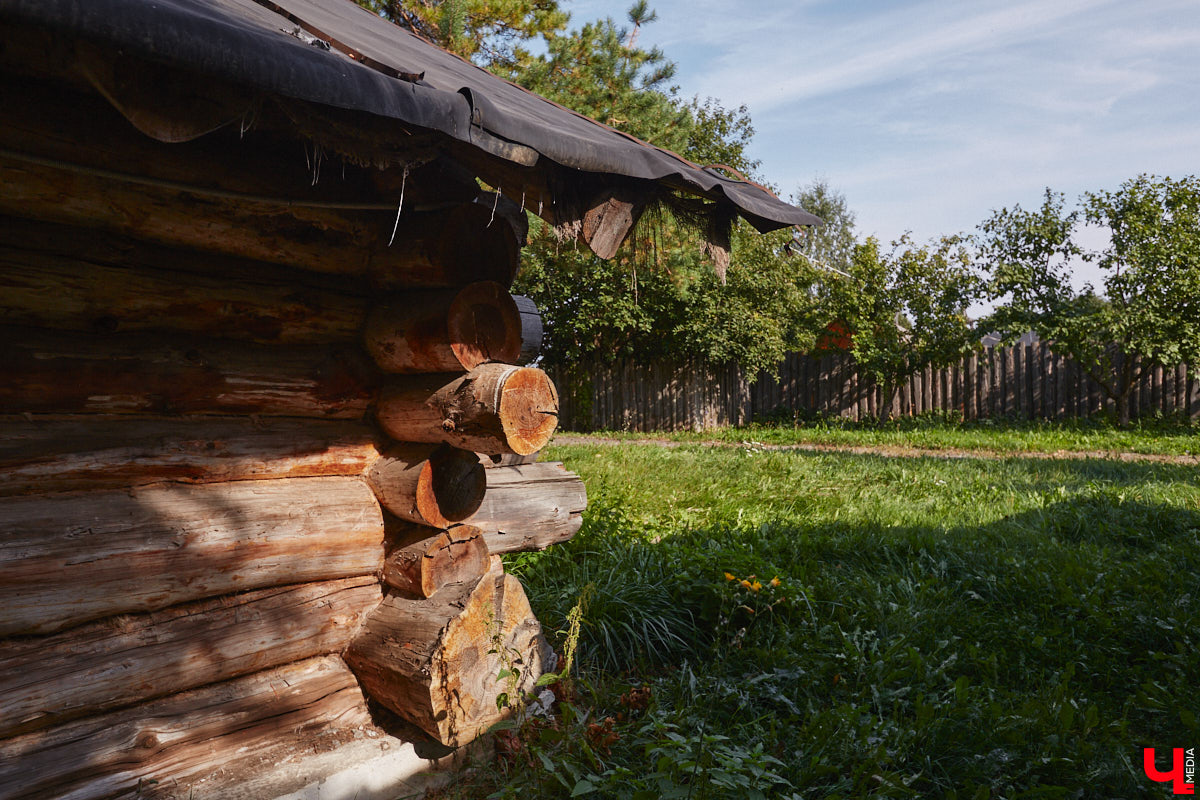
[{"x1": 346, "y1": 273, "x2": 558, "y2": 746}]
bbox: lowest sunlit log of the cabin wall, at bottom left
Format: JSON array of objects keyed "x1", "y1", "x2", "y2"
[{"x1": 0, "y1": 656, "x2": 372, "y2": 800}]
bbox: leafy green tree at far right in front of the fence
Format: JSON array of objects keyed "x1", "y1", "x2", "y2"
[{"x1": 977, "y1": 175, "x2": 1200, "y2": 425}]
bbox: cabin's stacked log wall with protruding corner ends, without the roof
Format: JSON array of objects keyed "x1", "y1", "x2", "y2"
[{"x1": 0, "y1": 65, "x2": 586, "y2": 798}]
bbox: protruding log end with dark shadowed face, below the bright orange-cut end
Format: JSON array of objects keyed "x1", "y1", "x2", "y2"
[{"x1": 367, "y1": 444, "x2": 487, "y2": 528}]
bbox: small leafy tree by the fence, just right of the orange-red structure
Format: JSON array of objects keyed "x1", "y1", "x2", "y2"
[{"x1": 828, "y1": 234, "x2": 980, "y2": 423}]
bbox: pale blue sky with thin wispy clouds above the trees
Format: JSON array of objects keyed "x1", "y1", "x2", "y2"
[{"x1": 564, "y1": 0, "x2": 1200, "y2": 291}]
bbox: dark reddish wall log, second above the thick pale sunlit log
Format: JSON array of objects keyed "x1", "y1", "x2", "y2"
[{"x1": 0, "y1": 327, "x2": 377, "y2": 419}]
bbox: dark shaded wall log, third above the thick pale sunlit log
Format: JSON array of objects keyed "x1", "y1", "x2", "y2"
[{"x1": 0, "y1": 235, "x2": 366, "y2": 343}]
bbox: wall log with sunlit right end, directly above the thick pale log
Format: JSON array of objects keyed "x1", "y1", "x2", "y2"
[{"x1": 0, "y1": 415, "x2": 381, "y2": 497}]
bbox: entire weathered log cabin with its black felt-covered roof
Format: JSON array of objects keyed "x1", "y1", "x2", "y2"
[{"x1": 0, "y1": 0, "x2": 816, "y2": 800}]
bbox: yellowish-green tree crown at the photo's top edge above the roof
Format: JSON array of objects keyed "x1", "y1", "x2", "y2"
[{"x1": 358, "y1": 0, "x2": 569, "y2": 67}]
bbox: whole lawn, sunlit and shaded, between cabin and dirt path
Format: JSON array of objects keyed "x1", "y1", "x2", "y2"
[{"x1": 441, "y1": 445, "x2": 1200, "y2": 800}]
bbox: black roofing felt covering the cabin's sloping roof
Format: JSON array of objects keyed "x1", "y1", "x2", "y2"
[{"x1": 0, "y1": 0, "x2": 820, "y2": 230}]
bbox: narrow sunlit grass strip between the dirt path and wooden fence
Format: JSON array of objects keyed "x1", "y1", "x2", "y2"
[{"x1": 564, "y1": 417, "x2": 1200, "y2": 456}]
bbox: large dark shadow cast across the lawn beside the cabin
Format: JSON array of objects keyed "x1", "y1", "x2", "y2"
[{"x1": 518, "y1": 494, "x2": 1200, "y2": 796}]
